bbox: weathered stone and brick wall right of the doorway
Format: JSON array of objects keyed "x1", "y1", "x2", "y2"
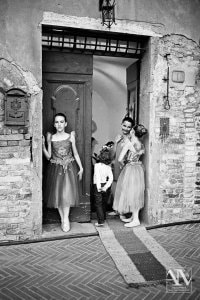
[{"x1": 150, "y1": 34, "x2": 200, "y2": 223}]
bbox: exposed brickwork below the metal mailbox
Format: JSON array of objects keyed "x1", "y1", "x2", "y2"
[{"x1": 0, "y1": 120, "x2": 32, "y2": 240}]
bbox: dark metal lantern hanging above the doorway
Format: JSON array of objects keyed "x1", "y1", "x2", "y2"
[{"x1": 99, "y1": 0, "x2": 115, "y2": 28}]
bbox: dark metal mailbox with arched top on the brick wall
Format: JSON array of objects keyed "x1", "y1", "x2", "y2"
[{"x1": 5, "y1": 88, "x2": 28, "y2": 125}]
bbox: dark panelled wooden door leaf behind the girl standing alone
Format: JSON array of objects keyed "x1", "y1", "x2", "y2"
[{"x1": 43, "y1": 51, "x2": 93, "y2": 222}]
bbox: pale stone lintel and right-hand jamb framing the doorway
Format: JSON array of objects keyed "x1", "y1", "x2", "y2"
[{"x1": 40, "y1": 12, "x2": 153, "y2": 223}]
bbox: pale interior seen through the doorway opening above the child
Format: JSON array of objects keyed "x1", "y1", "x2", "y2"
[{"x1": 91, "y1": 56, "x2": 138, "y2": 213}]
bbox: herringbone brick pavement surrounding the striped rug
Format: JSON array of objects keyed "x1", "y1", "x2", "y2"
[{"x1": 0, "y1": 224, "x2": 200, "y2": 300}]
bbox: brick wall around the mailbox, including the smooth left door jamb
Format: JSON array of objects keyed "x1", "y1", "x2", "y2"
[{"x1": 0, "y1": 59, "x2": 42, "y2": 241}]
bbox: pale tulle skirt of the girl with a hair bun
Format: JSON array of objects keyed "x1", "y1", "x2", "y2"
[{"x1": 113, "y1": 162, "x2": 145, "y2": 214}]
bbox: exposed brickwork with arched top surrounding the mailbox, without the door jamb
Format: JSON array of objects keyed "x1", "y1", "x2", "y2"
[{"x1": 0, "y1": 59, "x2": 41, "y2": 240}]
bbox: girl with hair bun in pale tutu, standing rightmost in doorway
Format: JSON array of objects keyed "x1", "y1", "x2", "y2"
[{"x1": 113, "y1": 125, "x2": 147, "y2": 227}]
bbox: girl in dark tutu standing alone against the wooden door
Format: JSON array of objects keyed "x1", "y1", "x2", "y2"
[{"x1": 43, "y1": 113, "x2": 83, "y2": 232}]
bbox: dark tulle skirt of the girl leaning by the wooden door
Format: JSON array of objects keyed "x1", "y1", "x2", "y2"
[{"x1": 44, "y1": 161, "x2": 79, "y2": 208}]
